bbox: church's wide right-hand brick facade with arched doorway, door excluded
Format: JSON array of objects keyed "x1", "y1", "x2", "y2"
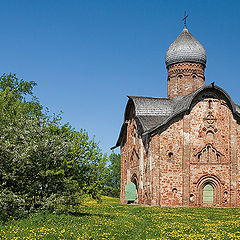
[{"x1": 154, "y1": 94, "x2": 239, "y2": 207}]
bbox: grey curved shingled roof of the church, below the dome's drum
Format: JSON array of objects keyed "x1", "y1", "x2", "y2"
[{"x1": 112, "y1": 84, "x2": 240, "y2": 149}]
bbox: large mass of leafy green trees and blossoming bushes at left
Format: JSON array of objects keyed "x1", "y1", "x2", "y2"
[{"x1": 0, "y1": 74, "x2": 106, "y2": 218}]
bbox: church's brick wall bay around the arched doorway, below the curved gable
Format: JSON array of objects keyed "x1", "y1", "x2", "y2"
[{"x1": 189, "y1": 93, "x2": 236, "y2": 206}]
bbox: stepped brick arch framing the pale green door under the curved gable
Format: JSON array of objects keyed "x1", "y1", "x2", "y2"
[{"x1": 197, "y1": 174, "x2": 222, "y2": 206}]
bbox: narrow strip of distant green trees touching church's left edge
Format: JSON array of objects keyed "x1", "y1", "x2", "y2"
[{"x1": 104, "y1": 153, "x2": 121, "y2": 197}]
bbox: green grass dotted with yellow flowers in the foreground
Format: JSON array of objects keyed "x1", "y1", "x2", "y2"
[{"x1": 0, "y1": 198, "x2": 240, "y2": 240}]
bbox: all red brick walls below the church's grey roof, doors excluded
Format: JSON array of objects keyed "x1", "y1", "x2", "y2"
[{"x1": 121, "y1": 92, "x2": 240, "y2": 207}]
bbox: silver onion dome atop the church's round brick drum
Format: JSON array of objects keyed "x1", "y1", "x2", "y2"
[{"x1": 165, "y1": 28, "x2": 207, "y2": 67}]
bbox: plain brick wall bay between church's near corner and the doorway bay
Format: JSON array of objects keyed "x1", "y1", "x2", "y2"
[{"x1": 150, "y1": 120, "x2": 183, "y2": 206}]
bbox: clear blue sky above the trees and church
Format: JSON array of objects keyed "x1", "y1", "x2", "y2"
[{"x1": 0, "y1": 0, "x2": 240, "y2": 152}]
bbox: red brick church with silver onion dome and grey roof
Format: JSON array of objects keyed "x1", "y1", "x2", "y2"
[{"x1": 113, "y1": 26, "x2": 240, "y2": 207}]
